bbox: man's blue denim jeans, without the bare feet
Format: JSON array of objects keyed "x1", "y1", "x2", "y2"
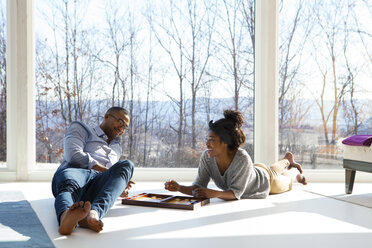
[{"x1": 52, "y1": 160, "x2": 134, "y2": 224}]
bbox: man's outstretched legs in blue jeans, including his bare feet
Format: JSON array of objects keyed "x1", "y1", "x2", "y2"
[{"x1": 52, "y1": 160, "x2": 133, "y2": 235}]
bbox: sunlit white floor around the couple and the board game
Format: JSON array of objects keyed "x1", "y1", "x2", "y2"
[{"x1": 0, "y1": 182, "x2": 372, "y2": 248}]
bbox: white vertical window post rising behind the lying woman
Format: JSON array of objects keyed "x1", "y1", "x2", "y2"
[{"x1": 254, "y1": 0, "x2": 279, "y2": 167}]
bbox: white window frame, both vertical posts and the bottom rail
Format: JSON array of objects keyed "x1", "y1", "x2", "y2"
[{"x1": 0, "y1": 0, "x2": 362, "y2": 182}]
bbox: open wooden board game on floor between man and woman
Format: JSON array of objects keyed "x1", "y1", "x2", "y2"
[{"x1": 121, "y1": 193, "x2": 209, "y2": 210}]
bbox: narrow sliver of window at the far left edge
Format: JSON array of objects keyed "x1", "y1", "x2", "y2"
[{"x1": 0, "y1": 0, "x2": 7, "y2": 169}]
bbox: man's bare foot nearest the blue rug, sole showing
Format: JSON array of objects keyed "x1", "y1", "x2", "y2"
[{"x1": 58, "y1": 201, "x2": 91, "y2": 235}]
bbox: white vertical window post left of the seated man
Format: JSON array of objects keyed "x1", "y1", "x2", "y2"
[{"x1": 6, "y1": 0, "x2": 36, "y2": 180}]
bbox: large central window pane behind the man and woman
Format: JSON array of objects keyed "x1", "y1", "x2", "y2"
[{"x1": 35, "y1": 0, "x2": 254, "y2": 168}]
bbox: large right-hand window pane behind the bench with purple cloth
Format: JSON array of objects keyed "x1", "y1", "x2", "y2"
[{"x1": 279, "y1": 0, "x2": 372, "y2": 169}]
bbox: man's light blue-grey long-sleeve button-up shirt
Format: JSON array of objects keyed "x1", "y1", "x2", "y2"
[{"x1": 60, "y1": 121, "x2": 122, "y2": 169}]
